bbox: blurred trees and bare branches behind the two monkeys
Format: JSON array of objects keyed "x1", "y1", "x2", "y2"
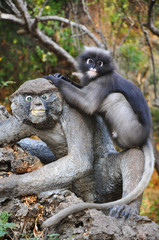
[{"x1": 0, "y1": 0, "x2": 159, "y2": 222}]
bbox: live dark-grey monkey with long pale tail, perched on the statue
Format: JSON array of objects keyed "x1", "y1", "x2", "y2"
[{"x1": 44, "y1": 47, "x2": 154, "y2": 225}]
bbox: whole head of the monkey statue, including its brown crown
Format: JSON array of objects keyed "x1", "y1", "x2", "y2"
[{"x1": 10, "y1": 78, "x2": 62, "y2": 128}]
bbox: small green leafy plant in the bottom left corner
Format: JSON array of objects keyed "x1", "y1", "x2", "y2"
[{"x1": 0, "y1": 212, "x2": 15, "y2": 237}]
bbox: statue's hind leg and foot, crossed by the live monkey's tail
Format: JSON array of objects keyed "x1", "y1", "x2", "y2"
[{"x1": 109, "y1": 149, "x2": 144, "y2": 219}]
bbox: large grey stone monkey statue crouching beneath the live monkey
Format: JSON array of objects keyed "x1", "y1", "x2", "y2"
[{"x1": 0, "y1": 79, "x2": 144, "y2": 229}]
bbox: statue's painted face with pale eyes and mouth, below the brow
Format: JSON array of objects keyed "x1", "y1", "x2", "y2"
[{"x1": 11, "y1": 92, "x2": 62, "y2": 128}]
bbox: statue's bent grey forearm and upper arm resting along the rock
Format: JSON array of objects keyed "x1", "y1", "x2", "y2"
[{"x1": 0, "y1": 106, "x2": 93, "y2": 201}]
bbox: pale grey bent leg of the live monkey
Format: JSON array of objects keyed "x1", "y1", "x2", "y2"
[{"x1": 100, "y1": 93, "x2": 144, "y2": 148}]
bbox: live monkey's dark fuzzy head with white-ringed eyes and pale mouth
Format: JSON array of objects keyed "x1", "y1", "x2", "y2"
[{"x1": 78, "y1": 47, "x2": 114, "y2": 79}]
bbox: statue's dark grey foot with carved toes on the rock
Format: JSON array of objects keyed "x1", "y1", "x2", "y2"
[{"x1": 109, "y1": 205, "x2": 139, "y2": 221}]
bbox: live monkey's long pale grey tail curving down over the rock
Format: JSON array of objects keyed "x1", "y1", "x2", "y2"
[{"x1": 42, "y1": 140, "x2": 154, "y2": 228}]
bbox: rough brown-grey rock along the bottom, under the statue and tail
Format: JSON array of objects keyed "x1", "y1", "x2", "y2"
[{"x1": 0, "y1": 189, "x2": 159, "y2": 240}]
